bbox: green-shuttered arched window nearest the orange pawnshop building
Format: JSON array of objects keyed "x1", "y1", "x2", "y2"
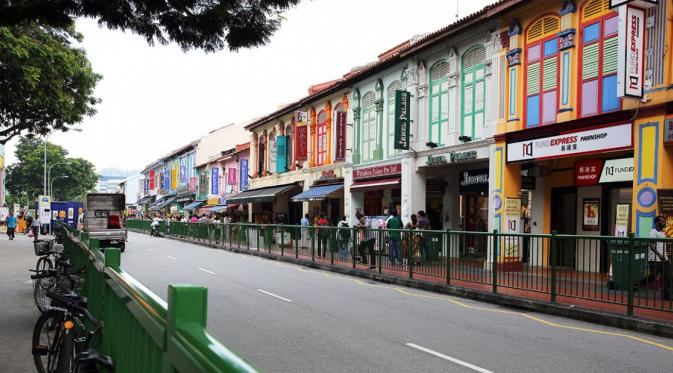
[{"x1": 460, "y1": 46, "x2": 486, "y2": 140}]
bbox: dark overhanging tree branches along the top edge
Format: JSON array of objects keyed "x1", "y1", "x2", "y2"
[{"x1": 0, "y1": 0, "x2": 299, "y2": 52}]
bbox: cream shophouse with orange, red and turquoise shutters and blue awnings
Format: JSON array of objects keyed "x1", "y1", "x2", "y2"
[{"x1": 231, "y1": 81, "x2": 349, "y2": 224}]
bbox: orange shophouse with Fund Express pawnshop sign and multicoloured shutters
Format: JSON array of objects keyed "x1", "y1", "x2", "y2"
[{"x1": 490, "y1": 0, "x2": 673, "y2": 272}]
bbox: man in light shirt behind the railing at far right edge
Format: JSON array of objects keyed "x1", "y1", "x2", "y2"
[{"x1": 647, "y1": 216, "x2": 673, "y2": 300}]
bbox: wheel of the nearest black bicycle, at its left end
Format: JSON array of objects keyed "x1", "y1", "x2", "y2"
[{"x1": 32, "y1": 310, "x2": 64, "y2": 373}]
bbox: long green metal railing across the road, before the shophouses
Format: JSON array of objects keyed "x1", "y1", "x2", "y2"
[{"x1": 127, "y1": 220, "x2": 673, "y2": 315}]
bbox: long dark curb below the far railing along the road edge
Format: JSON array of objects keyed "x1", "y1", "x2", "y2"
[{"x1": 133, "y1": 230, "x2": 673, "y2": 338}]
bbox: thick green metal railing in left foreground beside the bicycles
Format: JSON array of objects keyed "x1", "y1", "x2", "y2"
[{"x1": 64, "y1": 225, "x2": 256, "y2": 372}]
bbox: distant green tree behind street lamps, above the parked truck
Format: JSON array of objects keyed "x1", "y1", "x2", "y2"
[{"x1": 5, "y1": 137, "x2": 98, "y2": 201}]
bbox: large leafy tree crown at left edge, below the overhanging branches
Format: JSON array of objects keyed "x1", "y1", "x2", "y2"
[{"x1": 0, "y1": 23, "x2": 101, "y2": 144}]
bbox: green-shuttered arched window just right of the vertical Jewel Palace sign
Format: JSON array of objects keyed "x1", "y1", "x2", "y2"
[{"x1": 428, "y1": 61, "x2": 449, "y2": 145}]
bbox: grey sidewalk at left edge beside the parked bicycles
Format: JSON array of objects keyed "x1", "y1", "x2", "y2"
[{"x1": 0, "y1": 234, "x2": 45, "y2": 372}]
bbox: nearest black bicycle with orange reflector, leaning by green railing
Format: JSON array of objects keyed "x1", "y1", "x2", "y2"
[{"x1": 32, "y1": 292, "x2": 115, "y2": 373}]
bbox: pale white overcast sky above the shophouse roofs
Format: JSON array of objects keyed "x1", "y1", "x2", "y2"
[{"x1": 5, "y1": 0, "x2": 494, "y2": 170}]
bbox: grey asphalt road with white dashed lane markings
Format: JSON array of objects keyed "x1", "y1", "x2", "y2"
[{"x1": 122, "y1": 233, "x2": 673, "y2": 373}]
